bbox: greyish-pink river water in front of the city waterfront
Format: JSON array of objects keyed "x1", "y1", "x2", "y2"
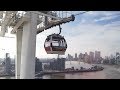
[{"x1": 0, "y1": 65, "x2": 120, "y2": 79}]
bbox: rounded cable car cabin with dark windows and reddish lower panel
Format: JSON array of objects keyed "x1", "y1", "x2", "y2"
[{"x1": 44, "y1": 34, "x2": 67, "y2": 55}]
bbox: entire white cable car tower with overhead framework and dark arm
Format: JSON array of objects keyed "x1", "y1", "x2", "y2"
[{"x1": 0, "y1": 11, "x2": 84, "y2": 79}]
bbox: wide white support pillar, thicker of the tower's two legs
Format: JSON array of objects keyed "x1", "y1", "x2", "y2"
[{"x1": 20, "y1": 13, "x2": 37, "y2": 79}]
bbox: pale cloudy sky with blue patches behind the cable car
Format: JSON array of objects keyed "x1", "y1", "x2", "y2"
[{"x1": 0, "y1": 11, "x2": 120, "y2": 58}]
